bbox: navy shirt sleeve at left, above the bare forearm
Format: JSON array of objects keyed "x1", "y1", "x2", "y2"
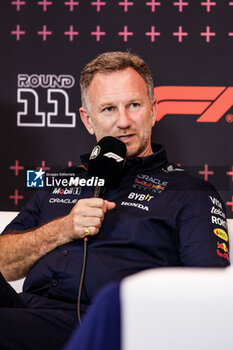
[{"x1": 2, "y1": 191, "x2": 48, "y2": 234}]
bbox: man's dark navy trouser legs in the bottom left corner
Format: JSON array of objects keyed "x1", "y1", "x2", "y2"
[{"x1": 0, "y1": 273, "x2": 77, "y2": 350}]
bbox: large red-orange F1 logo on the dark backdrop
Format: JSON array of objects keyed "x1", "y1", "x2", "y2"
[{"x1": 154, "y1": 86, "x2": 233, "y2": 123}]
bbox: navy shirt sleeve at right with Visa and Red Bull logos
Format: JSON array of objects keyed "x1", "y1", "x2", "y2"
[{"x1": 176, "y1": 183, "x2": 230, "y2": 267}]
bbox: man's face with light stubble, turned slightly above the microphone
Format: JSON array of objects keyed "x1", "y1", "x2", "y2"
[{"x1": 80, "y1": 68, "x2": 156, "y2": 158}]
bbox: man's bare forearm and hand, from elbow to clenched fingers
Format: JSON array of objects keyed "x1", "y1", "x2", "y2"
[{"x1": 0, "y1": 198, "x2": 115, "y2": 281}]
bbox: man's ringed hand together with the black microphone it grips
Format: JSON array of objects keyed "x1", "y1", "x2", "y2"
[{"x1": 66, "y1": 136, "x2": 126, "y2": 240}]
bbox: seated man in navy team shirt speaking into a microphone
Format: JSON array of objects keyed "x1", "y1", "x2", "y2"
[{"x1": 0, "y1": 52, "x2": 229, "y2": 350}]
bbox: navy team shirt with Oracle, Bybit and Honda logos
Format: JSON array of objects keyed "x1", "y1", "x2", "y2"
[{"x1": 2, "y1": 145, "x2": 229, "y2": 310}]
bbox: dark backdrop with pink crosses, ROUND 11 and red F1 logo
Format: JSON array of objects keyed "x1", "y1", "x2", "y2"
[{"x1": 0, "y1": 0, "x2": 233, "y2": 218}]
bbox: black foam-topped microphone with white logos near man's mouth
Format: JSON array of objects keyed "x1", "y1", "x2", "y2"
[{"x1": 88, "y1": 136, "x2": 126, "y2": 197}]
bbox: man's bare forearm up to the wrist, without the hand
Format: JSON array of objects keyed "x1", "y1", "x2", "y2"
[{"x1": 0, "y1": 217, "x2": 71, "y2": 281}]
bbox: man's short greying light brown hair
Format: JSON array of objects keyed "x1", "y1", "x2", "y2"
[{"x1": 80, "y1": 51, "x2": 154, "y2": 108}]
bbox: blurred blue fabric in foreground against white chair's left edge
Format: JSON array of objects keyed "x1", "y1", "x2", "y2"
[{"x1": 64, "y1": 283, "x2": 121, "y2": 350}]
